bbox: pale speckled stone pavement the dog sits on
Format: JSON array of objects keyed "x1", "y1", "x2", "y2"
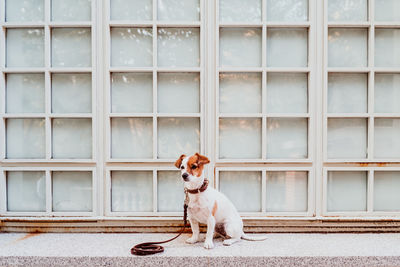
[{"x1": 0, "y1": 233, "x2": 400, "y2": 267}]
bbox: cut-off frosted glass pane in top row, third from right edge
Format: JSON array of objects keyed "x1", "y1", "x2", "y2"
[{"x1": 267, "y1": 0, "x2": 308, "y2": 21}]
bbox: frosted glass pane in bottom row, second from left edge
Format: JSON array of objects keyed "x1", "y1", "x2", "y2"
[{"x1": 52, "y1": 171, "x2": 93, "y2": 211}]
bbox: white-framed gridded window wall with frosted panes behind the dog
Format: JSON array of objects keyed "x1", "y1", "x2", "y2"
[{"x1": 0, "y1": 0, "x2": 400, "y2": 220}]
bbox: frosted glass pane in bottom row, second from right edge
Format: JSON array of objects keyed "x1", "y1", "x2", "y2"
[{"x1": 327, "y1": 171, "x2": 367, "y2": 211}]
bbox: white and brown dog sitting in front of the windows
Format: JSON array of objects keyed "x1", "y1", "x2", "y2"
[{"x1": 175, "y1": 153, "x2": 266, "y2": 249}]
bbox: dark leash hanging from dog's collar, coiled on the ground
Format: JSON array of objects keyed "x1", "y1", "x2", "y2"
[{"x1": 131, "y1": 193, "x2": 189, "y2": 256}]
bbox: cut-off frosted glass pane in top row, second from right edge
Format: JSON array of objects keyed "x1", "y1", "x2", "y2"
[{"x1": 328, "y1": 0, "x2": 368, "y2": 21}]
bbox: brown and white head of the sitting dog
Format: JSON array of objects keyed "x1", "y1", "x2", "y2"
[{"x1": 175, "y1": 153, "x2": 210, "y2": 183}]
